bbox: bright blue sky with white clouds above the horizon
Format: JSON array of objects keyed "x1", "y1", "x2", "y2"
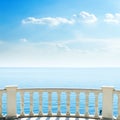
[{"x1": 0, "y1": 0, "x2": 120, "y2": 67}]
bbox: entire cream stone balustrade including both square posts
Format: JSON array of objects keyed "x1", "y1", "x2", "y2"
[{"x1": 0, "y1": 86, "x2": 120, "y2": 119}]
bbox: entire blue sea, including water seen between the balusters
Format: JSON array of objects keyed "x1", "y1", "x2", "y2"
[{"x1": 0, "y1": 68, "x2": 120, "y2": 116}]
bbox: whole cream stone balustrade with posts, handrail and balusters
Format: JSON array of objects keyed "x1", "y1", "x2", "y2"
[{"x1": 0, "y1": 86, "x2": 120, "y2": 119}]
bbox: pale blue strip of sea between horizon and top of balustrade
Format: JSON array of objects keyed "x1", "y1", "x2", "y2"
[{"x1": 0, "y1": 68, "x2": 120, "y2": 89}]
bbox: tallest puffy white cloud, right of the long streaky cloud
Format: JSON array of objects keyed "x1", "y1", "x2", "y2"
[{"x1": 73, "y1": 11, "x2": 97, "y2": 24}]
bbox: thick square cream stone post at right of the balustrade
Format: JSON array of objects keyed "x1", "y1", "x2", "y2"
[{"x1": 102, "y1": 86, "x2": 114, "y2": 119}]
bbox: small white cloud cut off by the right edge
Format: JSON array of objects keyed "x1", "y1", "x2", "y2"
[{"x1": 104, "y1": 13, "x2": 120, "y2": 24}]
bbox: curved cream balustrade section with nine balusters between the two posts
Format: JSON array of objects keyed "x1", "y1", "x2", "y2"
[{"x1": 17, "y1": 88, "x2": 102, "y2": 118}]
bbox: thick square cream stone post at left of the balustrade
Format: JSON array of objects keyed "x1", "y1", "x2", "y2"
[{"x1": 6, "y1": 86, "x2": 17, "y2": 117}]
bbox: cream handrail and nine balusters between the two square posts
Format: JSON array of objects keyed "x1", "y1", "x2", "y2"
[{"x1": 17, "y1": 88, "x2": 102, "y2": 118}]
